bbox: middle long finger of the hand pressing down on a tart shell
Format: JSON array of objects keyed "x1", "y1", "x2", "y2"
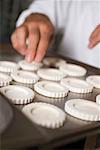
[{"x1": 25, "y1": 28, "x2": 40, "y2": 62}]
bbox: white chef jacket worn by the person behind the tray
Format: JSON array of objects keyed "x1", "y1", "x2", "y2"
[{"x1": 17, "y1": 0, "x2": 100, "y2": 68}]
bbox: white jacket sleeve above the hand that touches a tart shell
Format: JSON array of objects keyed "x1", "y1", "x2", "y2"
[{"x1": 16, "y1": 0, "x2": 59, "y2": 27}]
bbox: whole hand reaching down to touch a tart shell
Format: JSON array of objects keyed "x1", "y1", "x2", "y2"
[{"x1": 11, "y1": 14, "x2": 54, "y2": 62}]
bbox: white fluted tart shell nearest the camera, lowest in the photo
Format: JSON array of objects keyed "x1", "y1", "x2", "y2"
[{"x1": 22, "y1": 102, "x2": 66, "y2": 129}]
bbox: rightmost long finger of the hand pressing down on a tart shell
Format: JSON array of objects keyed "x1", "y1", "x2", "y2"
[{"x1": 35, "y1": 32, "x2": 51, "y2": 62}]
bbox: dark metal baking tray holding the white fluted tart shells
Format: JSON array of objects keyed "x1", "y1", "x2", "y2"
[{"x1": 0, "y1": 44, "x2": 100, "y2": 148}]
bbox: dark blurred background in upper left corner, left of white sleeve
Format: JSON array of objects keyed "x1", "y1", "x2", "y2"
[{"x1": 0, "y1": 0, "x2": 32, "y2": 43}]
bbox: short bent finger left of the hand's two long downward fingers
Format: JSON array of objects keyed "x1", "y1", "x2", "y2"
[{"x1": 16, "y1": 26, "x2": 28, "y2": 55}]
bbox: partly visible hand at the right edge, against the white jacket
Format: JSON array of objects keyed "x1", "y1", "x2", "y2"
[{"x1": 88, "y1": 24, "x2": 100, "y2": 48}]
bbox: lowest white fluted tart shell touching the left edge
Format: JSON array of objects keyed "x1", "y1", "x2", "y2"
[{"x1": 0, "y1": 85, "x2": 35, "y2": 104}]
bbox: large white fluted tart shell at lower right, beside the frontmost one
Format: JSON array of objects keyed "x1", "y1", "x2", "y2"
[{"x1": 65, "y1": 99, "x2": 100, "y2": 121}]
